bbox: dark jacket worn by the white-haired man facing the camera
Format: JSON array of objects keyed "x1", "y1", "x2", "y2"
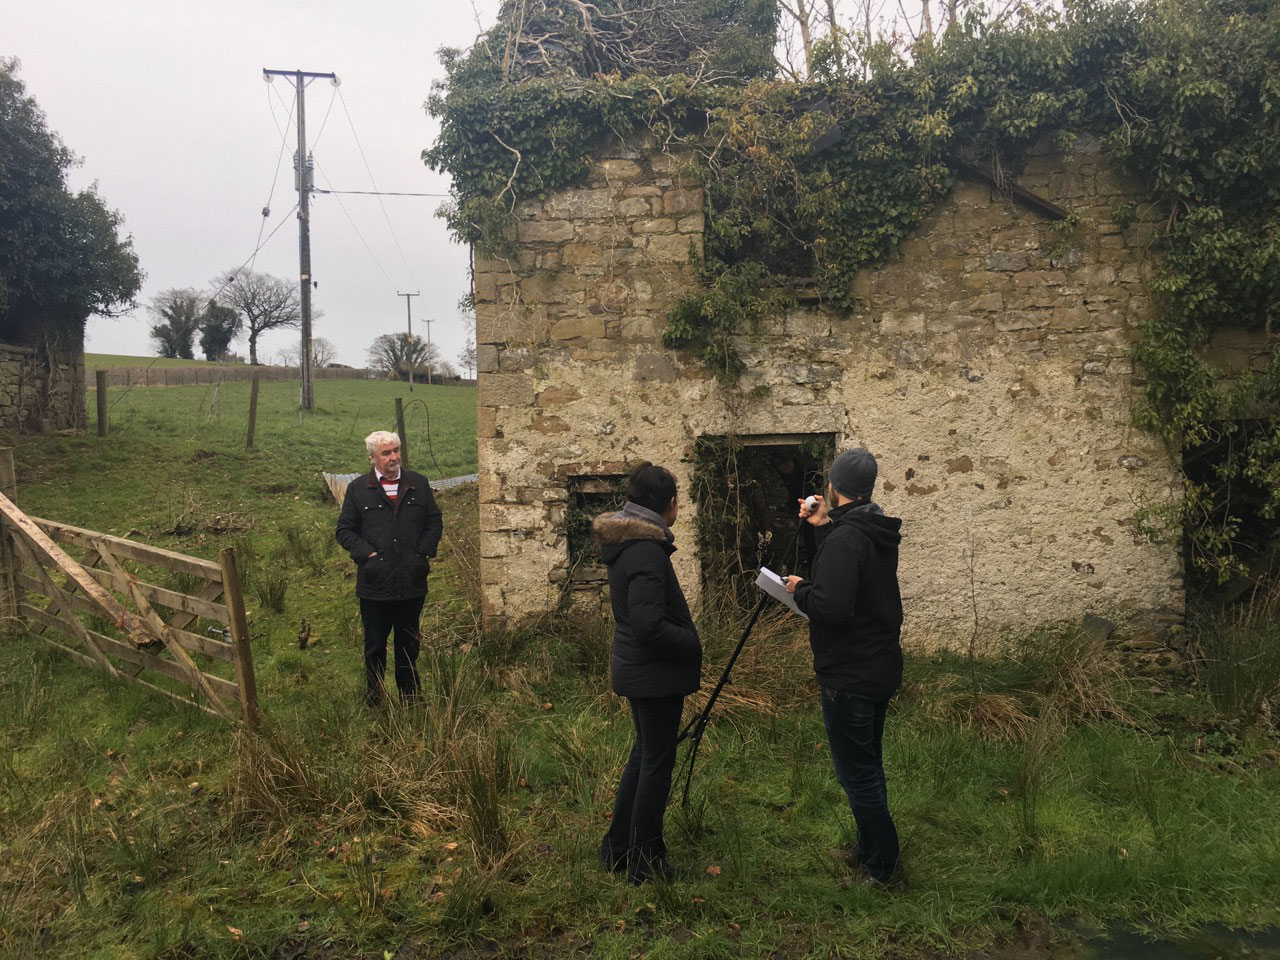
[{"x1": 337, "y1": 470, "x2": 444, "y2": 600}]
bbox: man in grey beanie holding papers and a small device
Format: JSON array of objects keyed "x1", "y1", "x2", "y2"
[{"x1": 787, "y1": 448, "x2": 902, "y2": 887}]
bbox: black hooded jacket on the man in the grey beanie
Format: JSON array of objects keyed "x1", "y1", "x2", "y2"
[{"x1": 795, "y1": 504, "x2": 902, "y2": 703}]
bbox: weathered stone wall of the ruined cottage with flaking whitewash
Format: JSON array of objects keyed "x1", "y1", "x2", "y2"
[{"x1": 475, "y1": 137, "x2": 1183, "y2": 644}]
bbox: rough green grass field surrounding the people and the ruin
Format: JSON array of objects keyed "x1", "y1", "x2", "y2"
[{"x1": 0, "y1": 381, "x2": 1280, "y2": 960}]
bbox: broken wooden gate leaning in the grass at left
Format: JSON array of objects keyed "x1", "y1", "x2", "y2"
[{"x1": 0, "y1": 493, "x2": 261, "y2": 726}]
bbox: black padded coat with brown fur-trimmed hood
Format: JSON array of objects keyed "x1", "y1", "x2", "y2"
[{"x1": 591, "y1": 513, "x2": 703, "y2": 698}]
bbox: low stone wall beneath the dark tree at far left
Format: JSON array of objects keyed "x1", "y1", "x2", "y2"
[{"x1": 0, "y1": 343, "x2": 84, "y2": 433}]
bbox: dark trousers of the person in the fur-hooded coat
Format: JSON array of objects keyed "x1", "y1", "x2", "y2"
[{"x1": 600, "y1": 696, "x2": 685, "y2": 883}]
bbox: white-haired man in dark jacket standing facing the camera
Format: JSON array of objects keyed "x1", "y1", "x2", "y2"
[{"x1": 337, "y1": 430, "x2": 444, "y2": 707}]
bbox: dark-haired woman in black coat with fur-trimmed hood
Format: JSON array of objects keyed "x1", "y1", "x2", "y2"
[{"x1": 591, "y1": 462, "x2": 703, "y2": 883}]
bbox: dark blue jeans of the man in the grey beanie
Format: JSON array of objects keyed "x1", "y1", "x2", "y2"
[{"x1": 822, "y1": 687, "x2": 899, "y2": 881}]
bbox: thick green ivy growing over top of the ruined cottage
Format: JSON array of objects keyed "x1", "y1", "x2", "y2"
[{"x1": 424, "y1": 0, "x2": 1280, "y2": 579}]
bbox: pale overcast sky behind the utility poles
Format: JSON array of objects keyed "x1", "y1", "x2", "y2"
[{"x1": 0, "y1": 0, "x2": 498, "y2": 365}]
